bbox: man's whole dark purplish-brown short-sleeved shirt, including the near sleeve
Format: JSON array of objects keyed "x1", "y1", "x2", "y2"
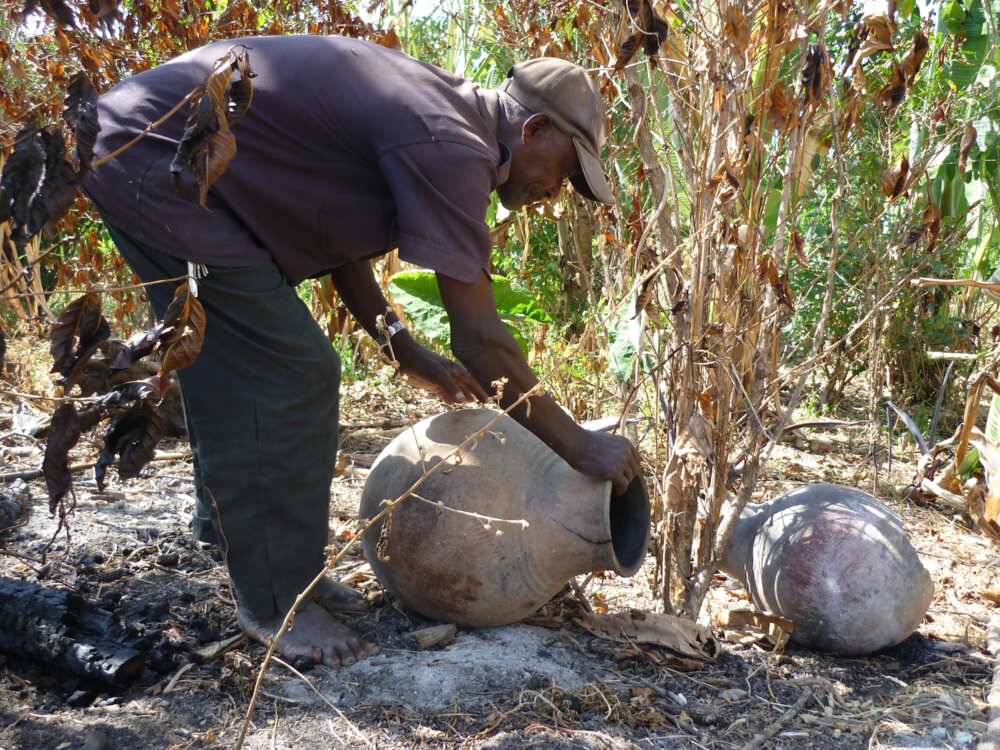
[{"x1": 83, "y1": 36, "x2": 509, "y2": 283}]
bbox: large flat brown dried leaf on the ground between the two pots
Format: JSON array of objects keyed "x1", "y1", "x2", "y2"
[{"x1": 577, "y1": 609, "x2": 719, "y2": 662}]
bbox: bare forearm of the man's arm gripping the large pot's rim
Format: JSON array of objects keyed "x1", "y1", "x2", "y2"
[{"x1": 452, "y1": 326, "x2": 582, "y2": 463}]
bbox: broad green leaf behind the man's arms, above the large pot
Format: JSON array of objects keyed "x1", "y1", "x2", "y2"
[{"x1": 389, "y1": 271, "x2": 552, "y2": 351}]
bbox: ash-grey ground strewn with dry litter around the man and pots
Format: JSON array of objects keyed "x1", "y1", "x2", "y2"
[{"x1": 0, "y1": 384, "x2": 1000, "y2": 750}]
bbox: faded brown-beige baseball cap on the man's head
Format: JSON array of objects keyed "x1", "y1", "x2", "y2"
[{"x1": 500, "y1": 57, "x2": 614, "y2": 203}]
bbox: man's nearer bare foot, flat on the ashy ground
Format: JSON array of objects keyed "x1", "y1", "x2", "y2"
[{"x1": 236, "y1": 602, "x2": 379, "y2": 667}]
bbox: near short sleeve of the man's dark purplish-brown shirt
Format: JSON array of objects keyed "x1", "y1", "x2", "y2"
[{"x1": 379, "y1": 141, "x2": 497, "y2": 283}]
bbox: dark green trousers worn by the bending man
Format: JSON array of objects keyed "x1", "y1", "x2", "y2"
[{"x1": 108, "y1": 225, "x2": 340, "y2": 617}]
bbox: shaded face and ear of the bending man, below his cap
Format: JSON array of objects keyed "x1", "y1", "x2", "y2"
[{"x1": 497, "y1": 115, "x2": 580, "y2": 211}]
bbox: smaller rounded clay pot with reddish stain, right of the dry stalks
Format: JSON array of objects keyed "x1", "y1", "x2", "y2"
[{"x1": 720, "y1": 484, "x2": 934, "y2": 656}]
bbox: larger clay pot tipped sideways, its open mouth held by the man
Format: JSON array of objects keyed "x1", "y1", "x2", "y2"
[{"x1": 361, "y1": 409, "x2": 649, "y2": 627}]
